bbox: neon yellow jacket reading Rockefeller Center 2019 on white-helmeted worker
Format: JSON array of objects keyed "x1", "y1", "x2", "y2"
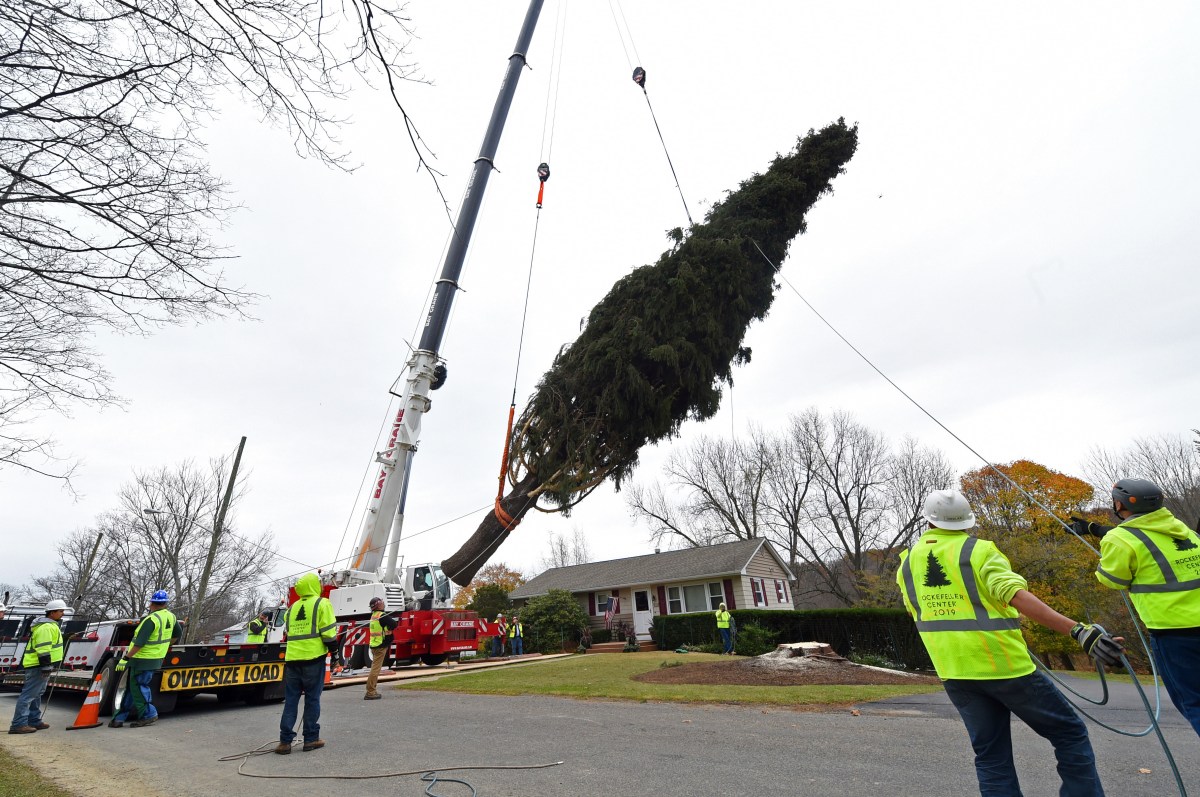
[{"x1": 896, "y1": 531, "x2": 1034, "y2": 681}]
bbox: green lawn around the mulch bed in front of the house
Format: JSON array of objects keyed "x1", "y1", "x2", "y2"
[{"x1": 398, "y1": 652, "x2": 941, "y2": 707}]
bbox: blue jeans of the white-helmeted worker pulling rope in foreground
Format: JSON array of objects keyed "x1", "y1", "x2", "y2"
[{"x1": 946, "y1": 672, "x2": 1104, "y2": 797}]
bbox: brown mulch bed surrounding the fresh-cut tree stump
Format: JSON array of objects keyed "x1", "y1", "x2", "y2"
[{"x1": 634, "y1": 659, "x2": 941, "y2": 687}]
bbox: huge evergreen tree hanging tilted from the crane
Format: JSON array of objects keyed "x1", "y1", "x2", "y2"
[{"x1": 442, "y1": 119, "x2": 858, "y2": 585}]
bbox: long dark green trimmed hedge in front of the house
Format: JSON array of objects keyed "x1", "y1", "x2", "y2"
[{"x1": 654, "y1": 609, "x2": 934, "y2": 670}]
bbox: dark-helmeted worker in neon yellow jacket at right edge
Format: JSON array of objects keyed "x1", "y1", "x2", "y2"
[{"x1": 1089, "y1": 479, "x2": 1200, "y2": 735}]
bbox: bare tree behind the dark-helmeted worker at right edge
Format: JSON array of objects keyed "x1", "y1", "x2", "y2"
[{"x1": 1084, "y1": 435, "x2": 1200, "y2": 526}]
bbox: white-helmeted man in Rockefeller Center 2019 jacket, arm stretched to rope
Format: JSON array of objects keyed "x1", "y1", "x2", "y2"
[{"x1": 896, "y1": 490, "x2": 1122, "y2": 797}]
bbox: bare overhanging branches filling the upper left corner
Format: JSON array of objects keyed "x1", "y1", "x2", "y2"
[{"x1": 0, "y1": 0, "x2": 432, "y2": 477}]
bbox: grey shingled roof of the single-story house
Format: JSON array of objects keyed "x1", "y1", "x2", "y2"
[{"x1": 510, "y1": 538, "x2": 791, "y2": 598}]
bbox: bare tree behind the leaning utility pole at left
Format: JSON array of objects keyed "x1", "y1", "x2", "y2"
[{"x1": 28, "y1": 460, "x2": 276, "y2": 639}]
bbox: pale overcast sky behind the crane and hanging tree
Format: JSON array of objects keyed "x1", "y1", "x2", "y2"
[{"x1": 0, "y1": 0, "x2": 1200, "y2": 583}]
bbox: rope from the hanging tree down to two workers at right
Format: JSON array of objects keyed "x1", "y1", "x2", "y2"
[{"x1": 750, "y1": 239, "x2": 1187, "y2": 797}]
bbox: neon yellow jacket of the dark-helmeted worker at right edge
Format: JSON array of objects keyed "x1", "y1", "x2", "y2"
[{"x1": 1096, "y1": 509, "x2": 1200, "y2": 630}]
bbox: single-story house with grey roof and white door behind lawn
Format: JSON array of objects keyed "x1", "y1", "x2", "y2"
[{"x1": 509, "y1": 539, "x2": 793, "y2": 639}]
